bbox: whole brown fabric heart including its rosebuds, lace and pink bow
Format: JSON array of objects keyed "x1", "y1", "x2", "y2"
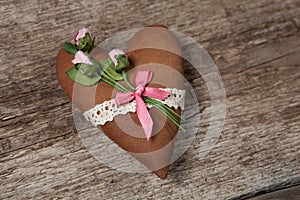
[{"x1": 56, "y1": 25, "x2": 184, "y2": 178}]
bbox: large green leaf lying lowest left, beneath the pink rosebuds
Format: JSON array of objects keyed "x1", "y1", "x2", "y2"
[{"x1": 66, "y1": 66, "x2": 101, "y2": 86}]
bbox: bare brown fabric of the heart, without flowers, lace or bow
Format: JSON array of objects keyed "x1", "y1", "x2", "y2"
[{"x1": 56, "y1": 25, "x2": 184, "y2": 179}]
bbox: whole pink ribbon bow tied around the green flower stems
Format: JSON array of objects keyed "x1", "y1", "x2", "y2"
[{"x1": 116, "y1": 70, "x2": 172, "y2": 140}]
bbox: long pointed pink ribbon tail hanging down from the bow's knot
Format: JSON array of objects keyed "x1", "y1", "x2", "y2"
[{"x1": 135, "y1": 94, "x2": 153, "y2": 140}]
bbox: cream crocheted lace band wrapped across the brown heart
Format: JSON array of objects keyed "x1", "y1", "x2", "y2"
[{"x1": 83, "y1": 88, "x2": 185, "y2": 126}]
